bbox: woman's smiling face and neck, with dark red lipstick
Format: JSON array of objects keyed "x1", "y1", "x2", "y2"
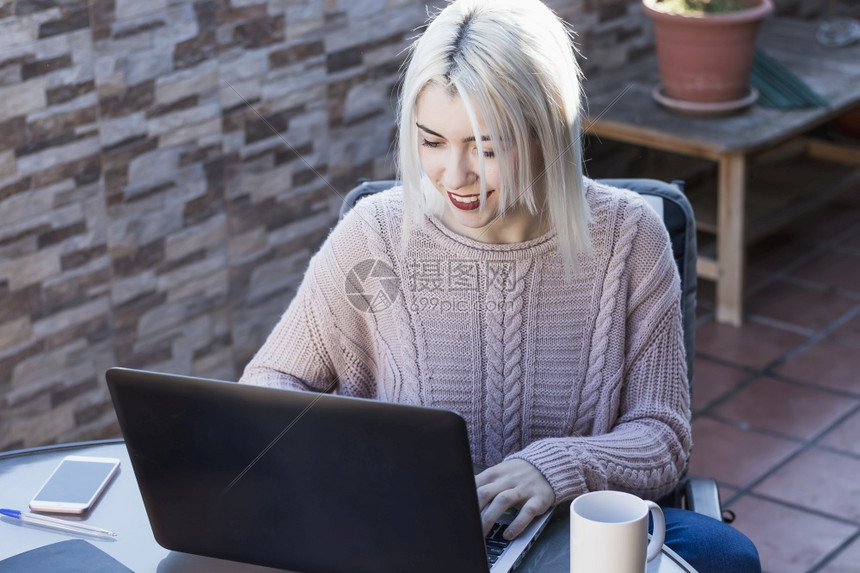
[{"x1": 416, "y1": 84, "x2": 542, "y2": 243}]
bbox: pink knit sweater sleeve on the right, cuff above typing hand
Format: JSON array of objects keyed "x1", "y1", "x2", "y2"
[{"x1": 509, "y1": 196, "x2": 692, "y2": 503}]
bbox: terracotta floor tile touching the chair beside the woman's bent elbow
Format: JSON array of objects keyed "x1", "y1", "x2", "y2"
[{"x1": 690, "y1": 416, "x2": 800, "y2": 488}]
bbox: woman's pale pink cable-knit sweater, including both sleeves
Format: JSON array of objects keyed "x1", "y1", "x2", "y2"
[{"x1": 241, "y1": 180, "x2": 691, "y2": 503}]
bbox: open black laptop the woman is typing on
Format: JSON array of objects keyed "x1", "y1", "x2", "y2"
[{"x1": 106, "y1": 368, "x2": 551, "y2": 573}]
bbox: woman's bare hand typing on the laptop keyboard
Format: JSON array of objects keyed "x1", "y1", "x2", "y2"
[{"x1": 475, "y1": 459, "x2": 555, "y2": 540}]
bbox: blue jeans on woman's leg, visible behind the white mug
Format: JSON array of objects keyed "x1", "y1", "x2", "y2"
[{"x1": 663, "y1": 507, "x2": 761, "y2": 573}]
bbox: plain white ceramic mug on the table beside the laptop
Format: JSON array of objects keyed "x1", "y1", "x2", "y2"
[{"x1": 570, "y1": 491, "x2": 666, "y2": 573}]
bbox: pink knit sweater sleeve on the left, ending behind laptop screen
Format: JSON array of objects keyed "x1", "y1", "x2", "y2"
[{"x1": 239, "y1": 209, "x2": 378, "y2": 397}]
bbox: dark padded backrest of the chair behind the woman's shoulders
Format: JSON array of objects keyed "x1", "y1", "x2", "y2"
[{"x1": 340, "y1": 179, "x2": 697, "y2": 386}]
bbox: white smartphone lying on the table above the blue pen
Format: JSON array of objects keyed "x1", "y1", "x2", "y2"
[{"x1": 30, "y1": 456, "x2": 119, "y2": 513}]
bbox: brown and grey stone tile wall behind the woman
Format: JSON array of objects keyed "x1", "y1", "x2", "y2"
[{"x1": 0, "y1": 0, "x2": 828, "y2": 450}]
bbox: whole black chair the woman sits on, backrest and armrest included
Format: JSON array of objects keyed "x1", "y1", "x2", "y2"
[{"x1": 340, "y1": 179, "x2": 732, "y2": 521}]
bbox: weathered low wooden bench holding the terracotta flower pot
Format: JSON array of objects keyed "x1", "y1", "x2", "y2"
[{"x1": 583, "y1": 18, "x2": 860, "y2": 326}]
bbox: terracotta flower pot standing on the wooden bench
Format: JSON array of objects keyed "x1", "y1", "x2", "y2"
[{"x1": 642, "y1": 0, "x2": 773, "y2": 103}]
